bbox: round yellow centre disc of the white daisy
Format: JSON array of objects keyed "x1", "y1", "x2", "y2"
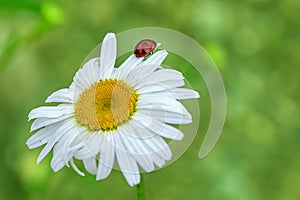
[{"x1": 75, "y1": 79, "x2": 137, "y2": 131}]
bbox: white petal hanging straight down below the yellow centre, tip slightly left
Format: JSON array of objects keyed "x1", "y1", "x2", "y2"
[{"x1": 96, "y1": 133, "x2": 115, "y2": 180}]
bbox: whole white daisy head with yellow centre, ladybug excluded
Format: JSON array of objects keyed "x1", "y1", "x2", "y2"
[{"x1": 26, "y1": 33, "x2": 199, "y2": 186}]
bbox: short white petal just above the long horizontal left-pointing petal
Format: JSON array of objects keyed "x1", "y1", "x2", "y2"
[{"x1": 46, "y1": 88, "x2": 74, "y2": 103}]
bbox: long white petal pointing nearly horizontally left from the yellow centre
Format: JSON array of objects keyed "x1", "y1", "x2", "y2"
[{"x1": 28, "y1": 104, "x2": 74, "y2": 120}]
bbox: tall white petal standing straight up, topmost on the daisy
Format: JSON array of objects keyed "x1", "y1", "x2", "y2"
[{"x1": 100, "y1": 33, "x2": 117, "y2": 79}]
